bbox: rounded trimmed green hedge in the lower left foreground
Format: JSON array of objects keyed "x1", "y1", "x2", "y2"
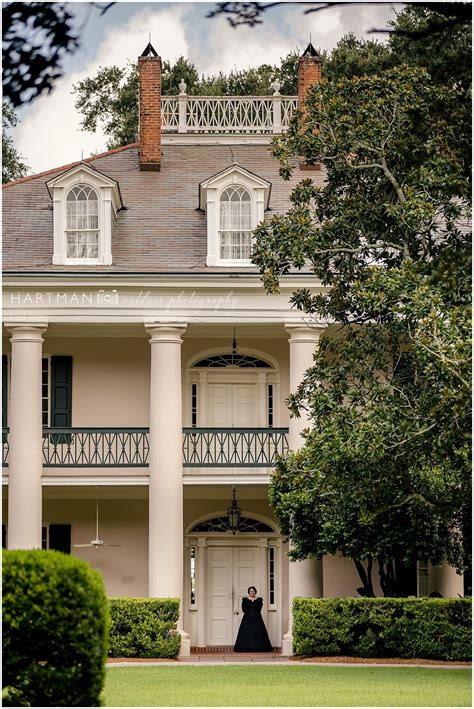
[{"x1": 3, "y1": 550, "x2": 109, "y2": 707}]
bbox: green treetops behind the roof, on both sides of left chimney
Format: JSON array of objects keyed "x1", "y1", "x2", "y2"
[{"x1": 74, "y1": 51, "x2": 298, "y2": 149}]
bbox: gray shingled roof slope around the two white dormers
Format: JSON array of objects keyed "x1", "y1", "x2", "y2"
[{"x1": 3, "y1": 145, "x2": 322, "y2": 273}]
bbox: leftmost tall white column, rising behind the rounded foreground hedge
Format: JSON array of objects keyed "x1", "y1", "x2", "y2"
[{"x1": 6, "y1": 323, "x2": 47, "y2": 549}]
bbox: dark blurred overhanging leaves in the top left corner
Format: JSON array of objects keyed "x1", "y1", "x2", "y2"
[{"x1": 2, "y1": 2, "x2": 115, "y2": 108}]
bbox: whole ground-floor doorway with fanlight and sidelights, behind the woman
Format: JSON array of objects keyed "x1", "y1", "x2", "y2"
[{"x1": 185, "y1": 512, "x2": 282, "y2": 648}]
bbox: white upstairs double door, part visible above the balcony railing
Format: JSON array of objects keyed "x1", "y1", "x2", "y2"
[{"x1": 207, "y1": 383, "x2": 259, "y2": 428}]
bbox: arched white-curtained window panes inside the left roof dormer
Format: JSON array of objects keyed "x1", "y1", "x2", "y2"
[{"x1": 66, "y1": 185, "x2": 99, "y2": 259}]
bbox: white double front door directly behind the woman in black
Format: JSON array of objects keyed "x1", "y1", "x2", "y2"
[{"x1": 207, "y1": 547, "x2": 259, "y2": 645}]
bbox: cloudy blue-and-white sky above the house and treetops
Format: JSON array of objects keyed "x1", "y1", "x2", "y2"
[{"x1": 12, "y1": 2, "x2": 401, "y2": 174}]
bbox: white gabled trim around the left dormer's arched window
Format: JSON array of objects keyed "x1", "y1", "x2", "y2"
[{"x1": 47, "y1": 164, "x2": 122, "y2": 266}]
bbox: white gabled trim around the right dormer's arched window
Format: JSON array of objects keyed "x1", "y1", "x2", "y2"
[{"x1": 199, "y1": 164, "x2": 270, "y2": 268}]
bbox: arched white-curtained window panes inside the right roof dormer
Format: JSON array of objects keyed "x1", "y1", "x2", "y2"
[{"x1": 219, "y1": 185, "x2": 252, "y2": 261}]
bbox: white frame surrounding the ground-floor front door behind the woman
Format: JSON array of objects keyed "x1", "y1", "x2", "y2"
[{"x1": 183, "y1": 532, "x2": 283, "y2": 647}]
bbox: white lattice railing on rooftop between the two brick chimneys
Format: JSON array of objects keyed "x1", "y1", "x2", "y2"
[{"x1": 161, "y1": 82, "x2": 298, "y2": 135}]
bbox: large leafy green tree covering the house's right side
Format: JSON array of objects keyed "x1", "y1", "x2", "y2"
[{"x1": 253, "y1": 60, "x2": 470, "y2": 595}]
